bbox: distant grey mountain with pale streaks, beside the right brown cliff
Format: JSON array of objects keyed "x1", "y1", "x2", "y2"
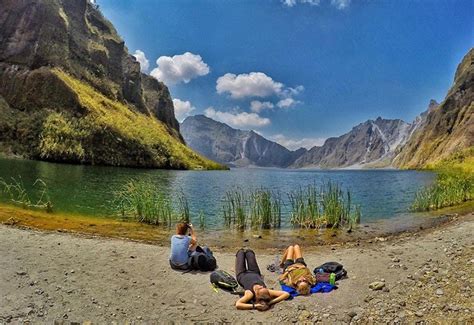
[{"x1": 291, "y1": 117, "x2": 411, "y2": 168}]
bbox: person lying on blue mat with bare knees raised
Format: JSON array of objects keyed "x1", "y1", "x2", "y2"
[{"x1": 280, "y1": 245, "x2": 316, "y2": 296}]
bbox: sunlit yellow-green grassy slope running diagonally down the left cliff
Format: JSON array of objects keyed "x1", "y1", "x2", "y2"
[{"x1": 53, "y1": 69, "x2": 224, "y2": 169}]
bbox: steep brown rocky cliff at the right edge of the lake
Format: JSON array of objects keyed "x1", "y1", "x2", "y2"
[{"x1": 394, "y1": 49, "x2": 474, "y2": 168}]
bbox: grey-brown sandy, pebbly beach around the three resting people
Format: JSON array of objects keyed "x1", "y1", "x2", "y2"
[{"x1": 0, "y1": 213, "x2": 474, "y2": 324}]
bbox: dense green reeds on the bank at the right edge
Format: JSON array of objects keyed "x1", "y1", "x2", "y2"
[{"x1": 411, "y1": 170, "x2": 474, "y2": 211}]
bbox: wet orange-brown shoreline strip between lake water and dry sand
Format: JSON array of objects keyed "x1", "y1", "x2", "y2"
[{"x1": 0, "y1": 201, "x2": 474, "y2": 251}]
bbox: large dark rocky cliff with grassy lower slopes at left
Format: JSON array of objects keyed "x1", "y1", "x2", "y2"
[{"x1": 0, "y1": 0, "x2": 215, "y2": 168}]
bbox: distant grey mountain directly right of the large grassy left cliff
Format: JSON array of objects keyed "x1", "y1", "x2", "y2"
[{"x1": 181, "y1": 115, "x2": 306, "y2": 167}]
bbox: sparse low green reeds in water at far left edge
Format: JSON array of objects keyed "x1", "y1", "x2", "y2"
[{"x1": 0, "y1": 177, "x2": 53, "y2": 213}]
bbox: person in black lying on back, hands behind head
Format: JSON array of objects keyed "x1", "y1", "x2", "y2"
[{"x1": 235, "y1": 249, "x2": 290, "y2": 311}]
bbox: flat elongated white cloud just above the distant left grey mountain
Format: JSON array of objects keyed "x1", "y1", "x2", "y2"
[{"x1": 204, "y1": 107, "x2": 271, "y2": 128}]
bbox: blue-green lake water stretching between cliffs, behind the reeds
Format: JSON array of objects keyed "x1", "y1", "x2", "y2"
[{"x1": 0, "y1": 158, "x2": 434, "y2": 228}]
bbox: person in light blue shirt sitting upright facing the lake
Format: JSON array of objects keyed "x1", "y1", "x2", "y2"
[{"x1": 170, "y1": 223, "x2": 197, "y2": 270}]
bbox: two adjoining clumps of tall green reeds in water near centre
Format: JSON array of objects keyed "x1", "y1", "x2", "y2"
[{"x1": 223, "y1": 182, "x2": 361, "y2": 230}]
